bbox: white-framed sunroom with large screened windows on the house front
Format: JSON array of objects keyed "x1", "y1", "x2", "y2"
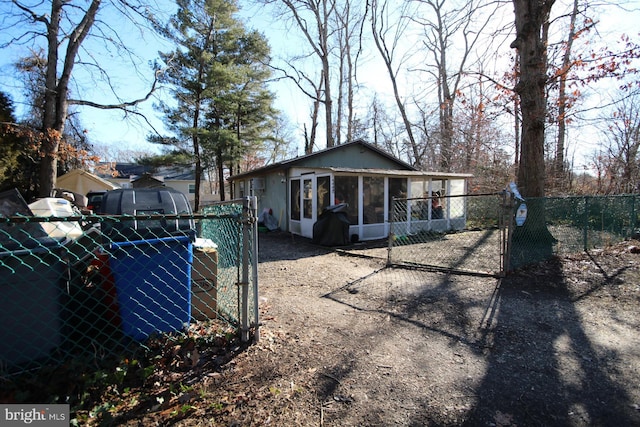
[{"x1": 288, "y1": 168, "x2": 468, "y2": 241}]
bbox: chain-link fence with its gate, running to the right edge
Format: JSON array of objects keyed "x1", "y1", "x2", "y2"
[{"x1": 388, "y1": 192, "x2": 640, "y2": 276}]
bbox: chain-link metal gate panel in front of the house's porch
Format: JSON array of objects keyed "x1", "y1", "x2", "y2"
[{"x1": 387, "y1": 192, "x2": 513, "y2": 276}]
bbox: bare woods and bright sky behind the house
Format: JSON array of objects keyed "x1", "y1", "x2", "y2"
[{"x1": 0, "y1": 0, "x2": 640, "y2": 207}]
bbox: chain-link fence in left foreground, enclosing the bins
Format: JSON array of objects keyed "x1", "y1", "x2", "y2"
[{"x1": 0, "y1": 198, "x2": 258, "y2": 373}]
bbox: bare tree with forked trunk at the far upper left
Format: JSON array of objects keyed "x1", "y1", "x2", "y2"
[{"x1": 0, "y1": 0, "x2": 162, "y2": 196}]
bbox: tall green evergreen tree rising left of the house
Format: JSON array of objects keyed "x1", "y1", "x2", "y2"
[{"x1": 160, "y1": 0, "x2": 276, "y2": 209}]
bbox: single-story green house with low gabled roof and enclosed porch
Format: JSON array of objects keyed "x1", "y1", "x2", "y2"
[{"x1": 229, "y1": 140, "x2": 471, "y2": 241}]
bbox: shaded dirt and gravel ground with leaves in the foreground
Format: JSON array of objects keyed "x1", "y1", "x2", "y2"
[{"x1": 55, "y1": 233, "x2": 640, "y2": 427}]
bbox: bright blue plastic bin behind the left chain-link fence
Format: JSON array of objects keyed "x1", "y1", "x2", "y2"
[{"x1": 109, "y1": 236, "x2": 193, "y2": 340}]
